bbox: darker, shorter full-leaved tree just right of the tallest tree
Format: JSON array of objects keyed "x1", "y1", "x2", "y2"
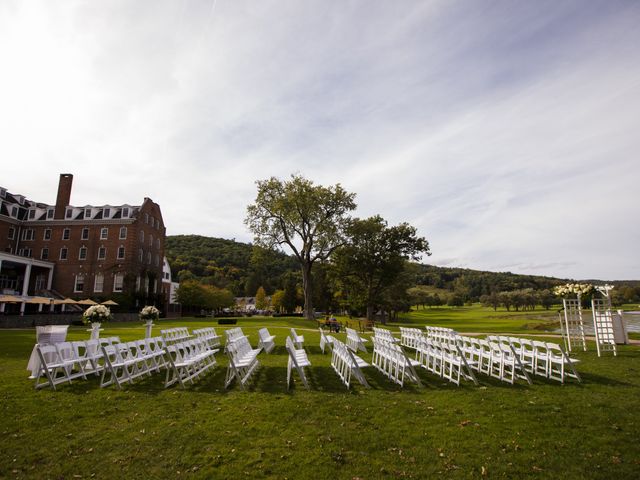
[{"x1": 333, "y1": 215, "x2": 431, "y2": 320}]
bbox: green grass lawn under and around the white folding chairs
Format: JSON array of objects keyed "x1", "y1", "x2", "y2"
[{"x1": 0, "y1": 314, "x2": 640, "y2": 479}]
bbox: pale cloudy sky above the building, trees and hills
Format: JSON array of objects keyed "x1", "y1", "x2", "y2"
[{"x1": 0, "y1": 0, "x2": 640, "y2": 280}]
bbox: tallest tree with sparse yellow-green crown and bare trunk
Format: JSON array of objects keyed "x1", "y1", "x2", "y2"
[{"x1": 245, "y1": 175, "x2": 356, "y2": 319}]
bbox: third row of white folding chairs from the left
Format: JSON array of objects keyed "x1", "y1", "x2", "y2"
[{"x1": 164, "y1": 337, "x2": 219, "y2": 388}]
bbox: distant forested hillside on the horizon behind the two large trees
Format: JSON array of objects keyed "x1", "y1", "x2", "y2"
[{"x1": 166, "y1": 235, "x2": 640, "y2": 299}]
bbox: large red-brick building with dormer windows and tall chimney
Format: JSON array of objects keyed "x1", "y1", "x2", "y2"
[{"x1": 0, "y1": 174, "x2": 166, "y2": 311}]
